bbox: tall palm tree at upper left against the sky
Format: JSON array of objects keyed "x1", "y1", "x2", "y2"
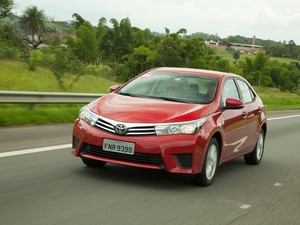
[{"x1": 20, "y1": 6, "x2": 47, "y2": 49}]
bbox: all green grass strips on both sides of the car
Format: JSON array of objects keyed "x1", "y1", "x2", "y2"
[{"x1": 0, "y1": 61, "x2": 300, "y2": 126}]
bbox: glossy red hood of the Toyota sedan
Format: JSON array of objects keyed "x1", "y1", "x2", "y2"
[{"x1": 89, "y1": 93, "x2": 210, "y2": 123}]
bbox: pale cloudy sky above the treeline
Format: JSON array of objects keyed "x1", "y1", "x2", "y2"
[{"x1": 13, "y1": 0, "x2": 300, "y2": 45}]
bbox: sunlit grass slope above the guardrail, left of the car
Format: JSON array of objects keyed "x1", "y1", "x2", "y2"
[{"x1": 0, "y1": 61, "x2": 116, "y2": 94}]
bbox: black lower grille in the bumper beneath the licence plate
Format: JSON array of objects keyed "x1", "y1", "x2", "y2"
[{"x1": 81, "y1": 144, "x2": 164, "y2": 169}]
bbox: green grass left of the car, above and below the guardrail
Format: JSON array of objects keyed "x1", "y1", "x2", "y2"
[{"x1": 0, "y1": 61, "x2": 116, "y2": 126}]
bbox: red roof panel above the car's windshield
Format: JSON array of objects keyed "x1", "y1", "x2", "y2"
[{"x1": 150, "y1": 67, "x2": 241, "y2": 78}]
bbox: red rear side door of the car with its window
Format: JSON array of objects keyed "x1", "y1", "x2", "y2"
[{"x1": 236, "y1": 79, "x2": 262, "y2": 152}]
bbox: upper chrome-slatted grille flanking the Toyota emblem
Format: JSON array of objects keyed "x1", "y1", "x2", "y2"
[{"x1": 94, "y1": 118, "x2": 156, "y2": 136}]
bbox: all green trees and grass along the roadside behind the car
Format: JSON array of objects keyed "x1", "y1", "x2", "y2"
[{"x1": 0, "y1": 0, "x2": 300, "y2": 126}]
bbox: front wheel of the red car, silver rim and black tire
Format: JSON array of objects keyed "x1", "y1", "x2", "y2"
[{"x1": 192, "y1": 138, "x2": 220, "y2": 187}]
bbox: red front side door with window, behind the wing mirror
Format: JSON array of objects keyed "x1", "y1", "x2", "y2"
[{"x1": 220, "y1": 78, "x2": 248, "y2": 161}]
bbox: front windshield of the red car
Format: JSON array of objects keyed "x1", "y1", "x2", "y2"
[{"x1": 117, "y1": 71, "x2": 219, "y2": 104}]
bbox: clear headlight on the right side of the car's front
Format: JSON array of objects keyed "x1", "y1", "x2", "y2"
[{"x1": 155, "y1": 118, "x2": 206, "y2": 135}]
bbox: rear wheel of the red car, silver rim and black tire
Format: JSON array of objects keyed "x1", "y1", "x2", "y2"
[{"x1": 244, "y1": 129, "x2": 265, "y2": 165}]
